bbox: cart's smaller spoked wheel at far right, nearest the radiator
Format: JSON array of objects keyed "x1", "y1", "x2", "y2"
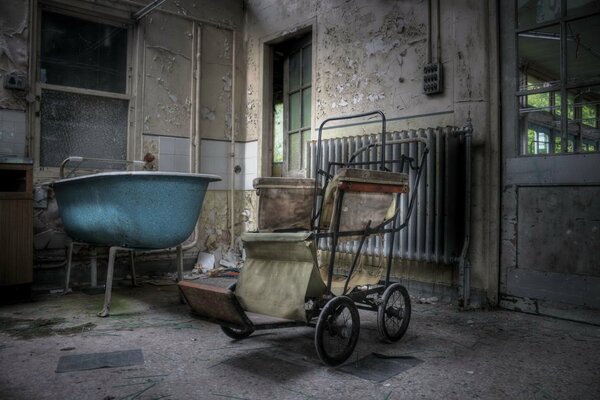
[{"x1": 377, "y1": 283, "x2": 410, "y2": 343}]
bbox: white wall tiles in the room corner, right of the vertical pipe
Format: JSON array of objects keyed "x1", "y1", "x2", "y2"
[{"x1": 200, "y1": 140, "x2": 258, "y2": 190}]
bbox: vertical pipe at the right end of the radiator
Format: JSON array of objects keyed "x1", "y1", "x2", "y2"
[{"x1": 455, "y1": 115, "x2": 473, "y2": 308}]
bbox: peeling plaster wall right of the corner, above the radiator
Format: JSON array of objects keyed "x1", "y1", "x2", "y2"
[{"x1": 245, "y1": 0, "x2": 500, "y2": 302}]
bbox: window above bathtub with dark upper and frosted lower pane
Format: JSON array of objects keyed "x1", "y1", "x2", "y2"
[{"x1": 38, "y1": 11, "x2": 129, "y2": 166}]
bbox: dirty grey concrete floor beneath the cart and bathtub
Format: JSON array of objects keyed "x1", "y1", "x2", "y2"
[{"x1": 0, "y1": 278, "x2": 600, "y2": 400}]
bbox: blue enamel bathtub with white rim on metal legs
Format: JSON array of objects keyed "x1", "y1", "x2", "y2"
[{"x1": 53, "y1": 171, "x2": 221, "y2": 249}]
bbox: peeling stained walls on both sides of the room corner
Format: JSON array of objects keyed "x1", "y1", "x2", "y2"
[{"x1": 0, "y1": 0, "x2": 500, "y2": 302}]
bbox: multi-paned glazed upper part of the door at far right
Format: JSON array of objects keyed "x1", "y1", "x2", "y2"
[{"x1": 515, "y1": 0, "x2": 600, "y2": 155}]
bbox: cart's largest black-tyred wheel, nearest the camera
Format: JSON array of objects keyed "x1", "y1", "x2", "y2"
[{"x1": 315, "y1": 296, "x2": 360, "y2": 366}]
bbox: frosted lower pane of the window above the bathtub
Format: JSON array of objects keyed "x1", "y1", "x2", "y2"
[{"x1": 40, "y1": 90, "x2": 129, "y2": 167}]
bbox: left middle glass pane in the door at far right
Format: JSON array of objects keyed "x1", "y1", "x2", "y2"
[{"x1": 518, "y1": 25, "x2": 560, "y2": 90}]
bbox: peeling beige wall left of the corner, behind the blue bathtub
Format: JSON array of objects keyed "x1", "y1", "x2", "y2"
[{"x1": 0, "y1": 0, "x2": 246, "y2": 288}]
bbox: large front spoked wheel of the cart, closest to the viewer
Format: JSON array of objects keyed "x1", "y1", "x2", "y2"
[{"x1": 315, "y1": 296, "x2": 360, "y2": 366}]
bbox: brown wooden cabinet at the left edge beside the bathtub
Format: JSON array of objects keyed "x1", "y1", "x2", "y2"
[{"x1": 0, "y1": 161, "x2": 33, "y2": 286}]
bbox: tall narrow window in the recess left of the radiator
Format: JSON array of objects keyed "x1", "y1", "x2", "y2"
[{"x1": 272, "y1": 33, "x2": 312, "y2": 176}]
